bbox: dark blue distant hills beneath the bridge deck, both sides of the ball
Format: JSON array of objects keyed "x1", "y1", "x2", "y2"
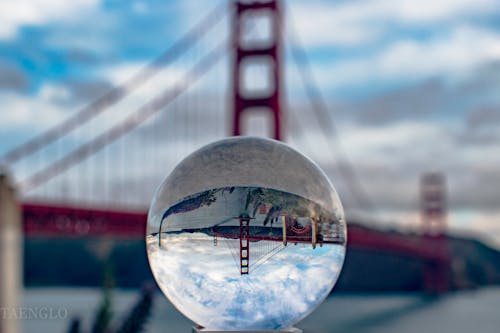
[{"x1": 24, "y1": 224, "x2": 500, "y2": 292}]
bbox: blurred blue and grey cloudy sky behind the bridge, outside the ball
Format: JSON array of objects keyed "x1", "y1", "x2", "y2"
[{"x1": 0, "y1": 0, "x2": 500, "y2": 244}]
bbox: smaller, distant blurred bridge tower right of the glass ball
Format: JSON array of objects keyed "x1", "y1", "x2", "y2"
[{"x1": 420, "y1": 173, "x2": 450, "y2": 293}]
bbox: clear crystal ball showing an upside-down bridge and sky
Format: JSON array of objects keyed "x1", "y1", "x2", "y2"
[{"x1": 146, "y1": 137, "x2": 346, "y2": 331}]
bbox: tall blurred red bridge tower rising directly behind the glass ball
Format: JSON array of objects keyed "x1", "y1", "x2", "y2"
[{"x1": 232, "y1": 0, "x2": 282, "y2": 140}]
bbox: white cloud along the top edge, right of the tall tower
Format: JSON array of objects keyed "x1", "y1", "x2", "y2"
[{"x1": 289, "y1": 0, "x2": 497, "y2": 47}]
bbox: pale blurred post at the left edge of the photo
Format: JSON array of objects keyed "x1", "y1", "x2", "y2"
[{"x1": 0, "y1": 174, "x2": 23, "y2": 333}]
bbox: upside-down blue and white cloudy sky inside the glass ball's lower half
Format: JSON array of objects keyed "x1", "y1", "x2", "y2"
[{"x1": 146, "y1": 233, "x2": 345, "y2": 330}]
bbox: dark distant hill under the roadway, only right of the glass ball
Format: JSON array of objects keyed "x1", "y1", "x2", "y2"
[{"x1": 335, "y1": 225, "x2": 500, "y2": 292}]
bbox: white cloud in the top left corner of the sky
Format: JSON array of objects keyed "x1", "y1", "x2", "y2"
[{"x1": 0, "y1": 0, "x2": 98, "y2": 39}]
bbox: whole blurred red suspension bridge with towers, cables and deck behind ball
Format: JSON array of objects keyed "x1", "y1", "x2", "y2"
[{"x1": 1, "y1": 0, "x2": 450, "y2": 291}]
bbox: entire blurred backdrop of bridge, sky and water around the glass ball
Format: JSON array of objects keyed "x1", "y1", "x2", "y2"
[{"x1": 0, "y1": 0, "x2": 500, "y2": 333}]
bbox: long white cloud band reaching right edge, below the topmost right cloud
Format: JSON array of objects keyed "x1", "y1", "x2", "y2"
[{"x1": 296, "y1": 26, "x2": 500, "y2": 89}]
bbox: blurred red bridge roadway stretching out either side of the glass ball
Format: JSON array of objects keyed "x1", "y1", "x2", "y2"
[{"x1": 22, "y1": 203, "x2": 449, "y2": 262}]
